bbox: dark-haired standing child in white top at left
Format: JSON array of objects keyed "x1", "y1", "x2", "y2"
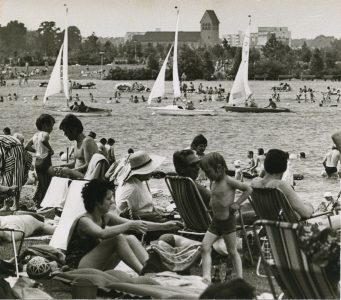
[{"x1": 26, "y1": 114, "x2": 56, "y2": 208}]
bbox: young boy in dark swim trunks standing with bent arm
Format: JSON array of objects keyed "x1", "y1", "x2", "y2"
[{"x1": 200, "y1": 152, "x2": 252, "y2": 283}]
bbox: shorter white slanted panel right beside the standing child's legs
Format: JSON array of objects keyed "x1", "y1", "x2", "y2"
[{"x1": 40, "y1": 176, "x2": 71, "y2": 207}]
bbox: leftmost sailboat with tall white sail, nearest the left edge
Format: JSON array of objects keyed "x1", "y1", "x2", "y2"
[{"x1": 43, "y1": 5, "x2": 111, "y2": 117}]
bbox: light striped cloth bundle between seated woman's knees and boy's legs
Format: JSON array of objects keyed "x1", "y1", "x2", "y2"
[{"x1": 148, "y1": 241, "x2": 201, "y2": 272}]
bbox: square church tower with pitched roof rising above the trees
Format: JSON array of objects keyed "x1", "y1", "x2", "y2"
[{"x1": 200, "y1": 10, "x2": 220, "y2": 46}]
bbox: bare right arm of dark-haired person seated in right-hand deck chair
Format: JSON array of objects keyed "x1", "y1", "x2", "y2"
[{"x1": 278, "y1": 181, "x2": 314, "y2": 218}]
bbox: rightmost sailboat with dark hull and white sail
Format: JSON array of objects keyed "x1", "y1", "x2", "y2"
[{"x1": 224, "y1": 16, "x2": 290, "y2": 113}]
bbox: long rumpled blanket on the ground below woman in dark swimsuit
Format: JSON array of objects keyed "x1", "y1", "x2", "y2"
[{"x1": 54, "y1": 269, "x2": 201, "y2": 299}]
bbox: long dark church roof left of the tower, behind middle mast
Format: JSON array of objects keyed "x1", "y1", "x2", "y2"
[{"x1": 133, "y1": 31, "x2": 201, "y2": 43}]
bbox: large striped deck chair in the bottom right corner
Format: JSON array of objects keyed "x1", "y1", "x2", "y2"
[{"x1": 254, "y1": 220, "x2": 340, "y2": 299}]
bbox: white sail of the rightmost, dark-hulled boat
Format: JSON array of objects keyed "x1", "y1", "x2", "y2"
[{"x1": 229, "y1": 20, "x2": 252, "y2": 106}]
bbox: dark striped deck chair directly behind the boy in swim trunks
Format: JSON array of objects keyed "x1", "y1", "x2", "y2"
[{"x1": 165, "y1": 175, "x2": 254, "y2": 265}]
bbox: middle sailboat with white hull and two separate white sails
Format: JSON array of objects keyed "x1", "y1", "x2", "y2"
[{"x1": 147, "y1": 7, "x2": 218, "y2": 116}]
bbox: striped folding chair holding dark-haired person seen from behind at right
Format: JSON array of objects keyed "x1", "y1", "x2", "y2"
[{"x1": 249, "y1": 188, "x2": 331, "y2": 277}]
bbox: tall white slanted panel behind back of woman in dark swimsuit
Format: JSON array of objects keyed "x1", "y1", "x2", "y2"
[{"x1": 49, "y1": 180, "x2": 87, "y2": 250}]
